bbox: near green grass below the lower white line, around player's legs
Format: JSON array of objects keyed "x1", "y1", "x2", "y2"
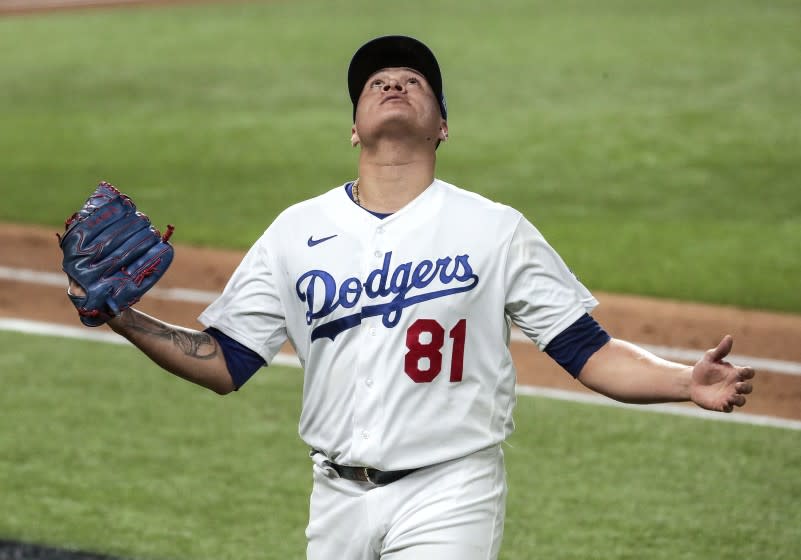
[{"x1": 0, "y1": 333, "x2": 801, "y2": 560}]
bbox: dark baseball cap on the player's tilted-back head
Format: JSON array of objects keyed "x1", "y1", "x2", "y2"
[{"x1": 348, "y1": 35, "x2": 448, "y2": 121}]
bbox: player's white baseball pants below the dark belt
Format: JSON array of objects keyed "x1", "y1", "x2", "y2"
[{"x1": 306, "y1": 445, "x2": 506, "y2": 560}]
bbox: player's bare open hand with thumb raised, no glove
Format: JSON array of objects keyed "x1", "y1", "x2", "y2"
[{"x1": 690, "y1": 334, "x2": 755, "y2": 412}]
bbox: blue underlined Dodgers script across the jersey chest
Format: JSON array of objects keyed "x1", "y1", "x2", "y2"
[{"x1": 295, "y1": 251, "x2": 478, "y2": 342}]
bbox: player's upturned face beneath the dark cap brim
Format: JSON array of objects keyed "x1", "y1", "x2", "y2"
[{"x1": 354, "y1": 68, "x2": 447, "y2": 149}]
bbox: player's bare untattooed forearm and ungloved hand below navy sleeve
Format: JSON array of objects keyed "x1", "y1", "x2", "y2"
[{"x1": 578, "y1": 335, "x2": 754, "y2": 412}]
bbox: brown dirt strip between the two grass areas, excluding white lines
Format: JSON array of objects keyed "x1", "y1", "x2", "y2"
[{"x1": 0, "y1": 224, "x2": 801, "y2": 419}]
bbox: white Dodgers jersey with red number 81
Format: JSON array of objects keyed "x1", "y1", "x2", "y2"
[{"x1": 200, "y1": 180, "x2": 597, "y2": 470}]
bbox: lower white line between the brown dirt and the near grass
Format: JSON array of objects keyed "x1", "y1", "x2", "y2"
[{"x1": 0, "y1": 318, "x2": 801, "y2": 431}]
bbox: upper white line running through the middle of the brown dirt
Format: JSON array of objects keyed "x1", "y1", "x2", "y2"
[{"x1": 0, "y1": 266, "x2": 801, "y2": 375}]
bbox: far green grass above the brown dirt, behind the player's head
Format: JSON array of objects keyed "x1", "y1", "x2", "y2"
[{"x1": 0, "y1": 0, "x2": 801, "y2": 312}]
